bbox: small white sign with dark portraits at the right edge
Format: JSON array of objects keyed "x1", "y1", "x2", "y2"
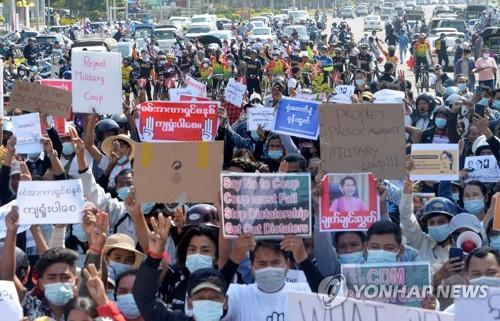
[{"x1": 464, "y1": 155, "x2": 500, "y2": 183}]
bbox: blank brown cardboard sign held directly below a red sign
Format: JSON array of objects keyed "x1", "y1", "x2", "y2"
[{"x1": 134, "y1": 141, "x2": 224, "y2": 203}]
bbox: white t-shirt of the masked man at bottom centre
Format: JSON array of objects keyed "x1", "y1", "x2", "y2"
[{"x1": 222, "y1": 283, "x2": 311, "y2": 321}]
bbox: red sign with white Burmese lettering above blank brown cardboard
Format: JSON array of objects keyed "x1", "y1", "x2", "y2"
[{"x1": 139, "y1": 101, "x2": 219, "y2": 142}]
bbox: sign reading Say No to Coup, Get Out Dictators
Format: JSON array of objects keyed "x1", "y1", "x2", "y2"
[{"x1": 221, "y1": 173, "x2": 312, "y2": 238}]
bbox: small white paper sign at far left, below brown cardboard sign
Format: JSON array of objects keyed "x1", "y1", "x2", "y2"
[{"x1": 12, "y1": 113, "x2": 43, "y2": 154}]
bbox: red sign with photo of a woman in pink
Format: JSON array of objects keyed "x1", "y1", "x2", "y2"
[{"x1": 319, "y1": 173, "x2": 380, "y2": 232}]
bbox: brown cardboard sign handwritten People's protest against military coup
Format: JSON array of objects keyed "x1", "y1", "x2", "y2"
[{"x1": 320, "y1": 104, "x2": 405, "y2": 179}]
